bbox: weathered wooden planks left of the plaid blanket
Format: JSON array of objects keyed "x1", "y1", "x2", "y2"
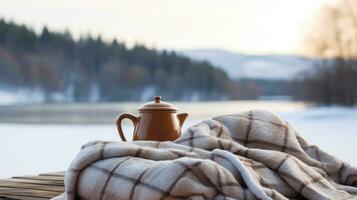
[{"x1": 0, "y1": 172, "x2": 65, "y2": 200}]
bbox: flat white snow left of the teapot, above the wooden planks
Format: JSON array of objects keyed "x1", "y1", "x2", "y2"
[{"x1": 0, "y1": 124, "x2": 119, "y2": 178}]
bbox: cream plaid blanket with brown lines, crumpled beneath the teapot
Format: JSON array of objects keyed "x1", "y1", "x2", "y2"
[{"x1": 53, "y1": 111, "x2": 357, "y2": 200}]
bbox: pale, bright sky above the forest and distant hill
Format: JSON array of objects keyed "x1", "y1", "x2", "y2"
[{"x1": 0, "y1": 0, "x2": 332, "y2": 54}]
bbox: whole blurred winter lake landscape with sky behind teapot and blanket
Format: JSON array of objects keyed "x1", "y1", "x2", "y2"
[{"x1": 0, "y1": 0, "x2": 357, "y2": 185}]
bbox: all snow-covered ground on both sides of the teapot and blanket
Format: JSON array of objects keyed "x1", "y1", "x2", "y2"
[{"x1": 0, "y1": 107, "x2": 357, "y2": 178}]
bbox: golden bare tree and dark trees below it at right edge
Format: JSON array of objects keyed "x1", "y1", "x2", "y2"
[{"x1": 294, "y1": 0, "x2": 357, "y2": 106}]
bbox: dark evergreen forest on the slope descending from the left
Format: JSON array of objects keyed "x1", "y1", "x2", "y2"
[{"x1": 0, "y1": 19, "x2": 238, "y2": 102}]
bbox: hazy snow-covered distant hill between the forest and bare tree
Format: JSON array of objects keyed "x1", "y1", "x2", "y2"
[{"x1": 180, "y1": 49, "x2": 318, "y2": 80}]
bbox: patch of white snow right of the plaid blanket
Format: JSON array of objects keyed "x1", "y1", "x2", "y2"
[{"x1": 281, "y1": 107, "x2": 357, "y2": 167}]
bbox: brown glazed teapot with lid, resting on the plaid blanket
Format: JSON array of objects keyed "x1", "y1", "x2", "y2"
[{"x1": 116, "y1": 96, "x2": 188, "y2": 141}]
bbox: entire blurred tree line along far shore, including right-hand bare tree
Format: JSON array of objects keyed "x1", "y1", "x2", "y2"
[{"x1": 0, "y1": 9, "x2": 357, "y2": 106}]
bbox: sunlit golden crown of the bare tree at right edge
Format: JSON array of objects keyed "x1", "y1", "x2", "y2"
[{"x1": 305, "y1": 0, "x2": 357, "y2": 59}]
